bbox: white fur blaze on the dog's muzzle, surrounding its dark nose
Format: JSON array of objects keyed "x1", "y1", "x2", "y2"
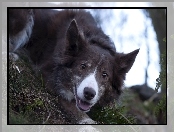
[{"x1": 77, "y1": 70, "x2": 98, "y2": 103}]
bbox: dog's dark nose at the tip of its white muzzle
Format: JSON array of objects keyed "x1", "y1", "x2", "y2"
[{"x1": 83, "y1": 87, "x2": 96, "y2": 100}]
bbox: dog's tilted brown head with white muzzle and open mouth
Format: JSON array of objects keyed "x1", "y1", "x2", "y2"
[{"x1": 47, "y1": 20, "x2": 139, "y2": 112}]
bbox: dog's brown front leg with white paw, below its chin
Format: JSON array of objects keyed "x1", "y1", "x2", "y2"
[{"x1": 59, "y1": 97, "x2": 96, "y2": 124}]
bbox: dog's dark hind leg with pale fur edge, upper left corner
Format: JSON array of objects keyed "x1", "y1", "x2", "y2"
[{"x1": 8, "y1": 9, "x2": 34, "y2": 61}]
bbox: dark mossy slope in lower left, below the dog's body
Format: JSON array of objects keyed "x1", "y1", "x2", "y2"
[{"x1": 8, "y1": 59, "x2": 69, "y2": 124}]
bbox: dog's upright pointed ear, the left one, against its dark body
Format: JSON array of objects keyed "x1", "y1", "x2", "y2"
[{"x1": 65, "y1": 19, "x2": 84, "y2": 56}]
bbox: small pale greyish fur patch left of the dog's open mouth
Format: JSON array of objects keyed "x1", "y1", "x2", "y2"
[{"x1": 60, "y1": 89, "x2": 74, "y2": 102}]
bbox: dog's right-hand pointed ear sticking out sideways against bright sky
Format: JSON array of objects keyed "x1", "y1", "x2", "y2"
[{"x1": 119, "y1": 49, "x2": 139, "y2": 73}]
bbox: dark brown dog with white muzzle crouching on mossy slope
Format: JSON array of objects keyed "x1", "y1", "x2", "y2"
[{"x1": 8, "y1": 9, "x2": 139, "y2": 124}]
